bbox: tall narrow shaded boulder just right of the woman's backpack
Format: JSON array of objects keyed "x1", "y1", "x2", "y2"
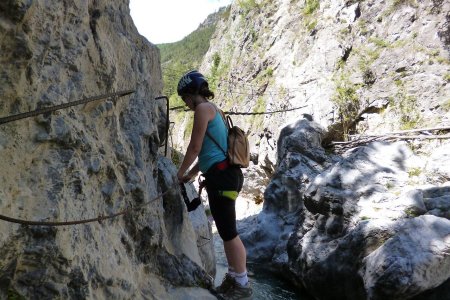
[{"x1": 239, "y1": 119, "x2": 331, "y2": 266}]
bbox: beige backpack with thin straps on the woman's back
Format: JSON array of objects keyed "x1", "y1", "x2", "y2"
[{"x1": 206, "y1": 109, "x2": 250, "y2": 168}]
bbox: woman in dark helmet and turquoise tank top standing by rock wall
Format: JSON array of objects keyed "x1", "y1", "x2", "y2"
[{"x1": 177, "y1": 71, "x2": 252, "y2": 299}]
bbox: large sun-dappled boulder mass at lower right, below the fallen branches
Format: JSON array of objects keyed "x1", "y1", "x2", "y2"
[{"x1": 288, "y1": 143, "x2": 450, "y2": 299}]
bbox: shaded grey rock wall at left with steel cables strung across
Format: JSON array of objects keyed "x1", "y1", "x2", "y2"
[{"x1": 0, "y1": 0, "x2": 215, "y2": 299}]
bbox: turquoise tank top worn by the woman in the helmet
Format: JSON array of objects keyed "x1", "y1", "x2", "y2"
[{"x1": 198, "y1": 109, "x2": 228, "y2": 173}]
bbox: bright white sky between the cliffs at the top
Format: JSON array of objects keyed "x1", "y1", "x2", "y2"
[{"x1": 130, "y1": 0, "x2": 232, "y2": 44}]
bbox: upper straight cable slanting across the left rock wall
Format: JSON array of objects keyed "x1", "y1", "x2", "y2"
[{"x1": 0, "y1": 90, "x2": 135, "y2": 125}]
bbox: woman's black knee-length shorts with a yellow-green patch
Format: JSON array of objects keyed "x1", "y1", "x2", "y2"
[{"x1": 205, "y1": 162, "x2": 244, "y2": 242}]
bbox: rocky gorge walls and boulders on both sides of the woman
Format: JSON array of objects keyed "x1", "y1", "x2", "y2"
[{"x1": 0, "y1": 0, "x2": 450, "y2": 300}]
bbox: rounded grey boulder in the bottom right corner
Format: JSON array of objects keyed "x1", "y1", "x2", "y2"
[{"x1": 361, "y1": 216, "x2": 450, "y2": 299}]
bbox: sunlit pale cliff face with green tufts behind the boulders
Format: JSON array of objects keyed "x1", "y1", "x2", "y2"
[{"x1": 201, "y1": 0, "x2": 450, "y2": 203}]
